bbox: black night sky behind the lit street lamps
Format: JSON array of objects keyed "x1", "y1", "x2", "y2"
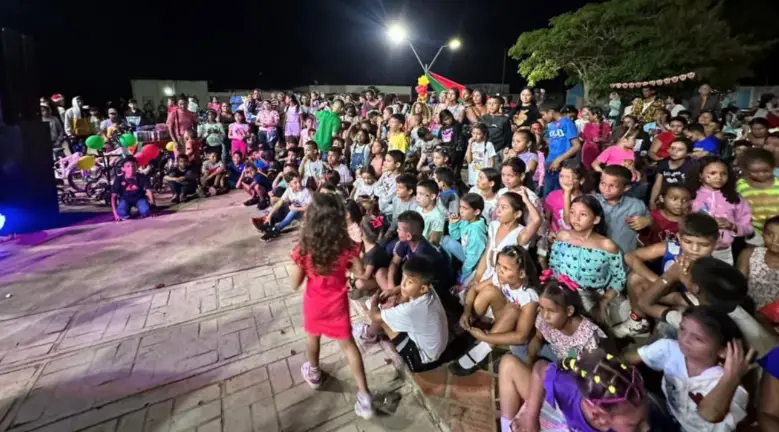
[{"x1": 0, "y1": 0, "x2": 771, "y2": 99}]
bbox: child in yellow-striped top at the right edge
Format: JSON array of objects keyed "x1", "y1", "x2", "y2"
[{"x1": 736, "y1": 148, "x2": 779, "y2": 246}]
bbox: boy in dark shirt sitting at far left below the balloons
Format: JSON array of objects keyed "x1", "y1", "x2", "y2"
[{"x1": 111, "y1": 156, "x2": 154, "y2": 222}]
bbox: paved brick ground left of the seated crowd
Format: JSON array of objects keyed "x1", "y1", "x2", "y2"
[{"x1": 0, "y1": 194, "x2": 435, "y2": 432}]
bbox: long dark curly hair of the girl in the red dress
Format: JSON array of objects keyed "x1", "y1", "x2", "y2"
[{"x1": 300, "y1": 193, "x2": 354, "y2": 276}]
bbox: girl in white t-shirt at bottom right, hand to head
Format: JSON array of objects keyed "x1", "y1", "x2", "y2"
[{"x1": 625, "y1": 306, "x2": 754, "y2": 432}]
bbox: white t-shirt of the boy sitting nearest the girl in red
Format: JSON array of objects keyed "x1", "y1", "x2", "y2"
[{"x1": 381, "y1": 289, "x2": 449, "y2": 363}]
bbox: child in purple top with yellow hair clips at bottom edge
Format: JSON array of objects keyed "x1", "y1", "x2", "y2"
[{"x1": 498, "y1": 349, "x2": 647, "y2": 432}]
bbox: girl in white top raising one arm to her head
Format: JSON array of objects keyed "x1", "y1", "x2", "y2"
[{"x1": 471, "y1": 192, "x2": 542, "y2": 286}]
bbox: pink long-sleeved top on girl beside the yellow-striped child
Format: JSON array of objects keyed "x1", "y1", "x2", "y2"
[{"x1": 692, "y1": 186, "x2": 753, "y2": 250}]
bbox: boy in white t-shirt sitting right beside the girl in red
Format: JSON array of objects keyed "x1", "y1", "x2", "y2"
[{"x1": 361, "y1": 257, "x2": 449, "y2": 372}]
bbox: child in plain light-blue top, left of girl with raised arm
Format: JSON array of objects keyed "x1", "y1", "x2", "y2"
[{"x1": 441, "y1": 193, "x2": 487, "y2": 285}]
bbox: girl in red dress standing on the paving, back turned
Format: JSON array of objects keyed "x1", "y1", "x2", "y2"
[{"x1": 290, "y1": 192, "x2": 373, "y2": 419}]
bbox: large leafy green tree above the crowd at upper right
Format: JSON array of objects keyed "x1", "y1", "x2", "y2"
[{"x1": 509, "y1": 0, "x2": 765, "y2": 100}]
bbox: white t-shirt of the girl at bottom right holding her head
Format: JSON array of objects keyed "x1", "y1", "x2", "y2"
[{"x1": 638, "y1": 339, "x2": 749, "y2": 432}]
